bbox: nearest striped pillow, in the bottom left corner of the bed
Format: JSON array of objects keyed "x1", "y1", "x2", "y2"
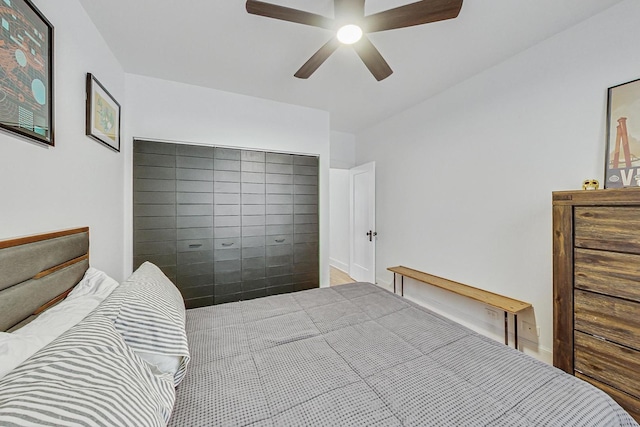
[{"x1": 0, "y1": 313, "x2": 175, "y2": 426}]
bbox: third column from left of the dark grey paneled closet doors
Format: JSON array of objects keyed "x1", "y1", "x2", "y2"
[{"x1": 213, "y1": 147, "x2": 242, "y2": 304}]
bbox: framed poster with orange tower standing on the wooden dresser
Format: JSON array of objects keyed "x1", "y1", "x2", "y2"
[{"x1": 604, "y1": 79, "x2": 640, "y2": 188}]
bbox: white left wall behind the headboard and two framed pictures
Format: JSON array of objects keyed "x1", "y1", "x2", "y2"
[{"x1": 0, "y1": 0, "x2": 126, "y2": 279}]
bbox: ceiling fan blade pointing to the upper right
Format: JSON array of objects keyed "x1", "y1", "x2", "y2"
[{"x1": 364, "y1": 0, "x2": 462, "y2": 33}]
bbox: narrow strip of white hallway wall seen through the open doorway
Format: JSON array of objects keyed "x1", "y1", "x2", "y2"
[{"x1": 329, "y1": 169, "x2": 351, "y2": 273}]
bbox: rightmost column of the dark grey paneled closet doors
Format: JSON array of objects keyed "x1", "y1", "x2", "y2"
[{"x1": 293, "y1": 156, "x2": 320, "y2": 291}]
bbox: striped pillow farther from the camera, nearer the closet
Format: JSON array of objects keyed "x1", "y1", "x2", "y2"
[{"x1": 101, "y1": 262, "x2": 190, "y2": 386}]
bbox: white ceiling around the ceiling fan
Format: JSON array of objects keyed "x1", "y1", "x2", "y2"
[{"x1": 80, "y1": 0, "x2": 622, "y2": 133}]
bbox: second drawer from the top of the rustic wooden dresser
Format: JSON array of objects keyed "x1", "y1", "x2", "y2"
[{"x1": 574, "y1": 249, "x2": 640, "y2": 302}]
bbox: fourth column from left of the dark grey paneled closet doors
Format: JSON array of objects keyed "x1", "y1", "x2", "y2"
[{"x1": 240, "y1": 151, "x2": 266, "y2": 299}]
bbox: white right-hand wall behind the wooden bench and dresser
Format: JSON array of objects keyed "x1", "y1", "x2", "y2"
[{"x1": 357, "y1": 0, "x2": 640, "y2": 361}]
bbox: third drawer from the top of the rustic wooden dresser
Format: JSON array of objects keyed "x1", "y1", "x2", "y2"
[{"x1": 574, "y1": 289, "x2": 640, "y2": 350}]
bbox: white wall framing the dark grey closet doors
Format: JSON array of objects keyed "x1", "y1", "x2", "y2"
[{"x1": 125, "y1": 74, "x2": 329, "y2": 286}]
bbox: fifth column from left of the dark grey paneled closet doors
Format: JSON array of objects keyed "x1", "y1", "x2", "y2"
[{"x1": 266, "y1": 153, "x2": 293, "y2": 295}]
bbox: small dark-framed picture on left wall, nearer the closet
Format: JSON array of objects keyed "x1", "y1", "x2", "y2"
[{"x1": 86, "y1": 73, "x2": 120, "y2": 151}]
